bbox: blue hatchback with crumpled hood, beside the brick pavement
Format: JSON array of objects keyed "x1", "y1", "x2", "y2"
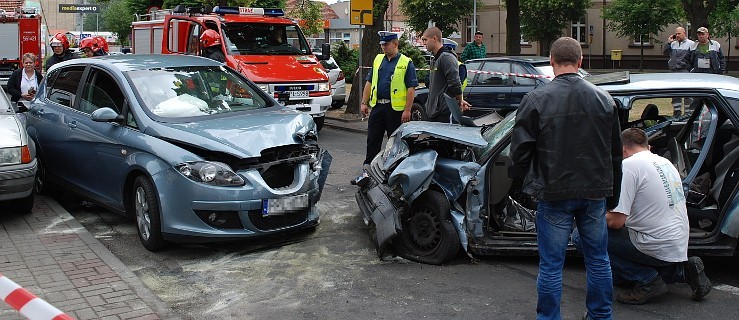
[{"x1": 26, "y1": 55, "x2": 331, "y2": 251}]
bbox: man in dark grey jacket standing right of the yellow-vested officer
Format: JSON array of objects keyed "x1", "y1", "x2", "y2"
[{"x1": 421, "y1": 27, "x2": 470, "y2": 122}]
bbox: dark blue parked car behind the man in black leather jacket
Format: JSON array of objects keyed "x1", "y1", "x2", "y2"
[{"x1": 412, "y1": 56, "x2": 589, "y2": 120}]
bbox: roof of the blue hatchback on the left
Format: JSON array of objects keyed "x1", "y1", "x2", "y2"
[{"x1": 53, "y1": 54, "x2": 222, "y2": 72}]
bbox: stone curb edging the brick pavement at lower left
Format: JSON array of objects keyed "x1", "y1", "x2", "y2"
[{"x1": 43, "y1": 196, "x2": 182, "y2": 320}]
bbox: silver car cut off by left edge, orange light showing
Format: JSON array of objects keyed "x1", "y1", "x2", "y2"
[{"x1": 0, "y1": 89, "x2": 36, "y2": 213}]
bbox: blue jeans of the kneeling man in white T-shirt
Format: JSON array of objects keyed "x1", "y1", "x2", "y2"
[{"x1": 572, "y1": 227, "x2": 685, "y2": 285}]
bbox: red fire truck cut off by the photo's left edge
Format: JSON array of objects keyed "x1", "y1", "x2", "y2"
[{"x1": 0, "y1": 8, "x2": 44, "y2": 86}]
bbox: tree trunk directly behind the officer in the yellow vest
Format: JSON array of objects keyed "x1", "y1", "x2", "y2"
[{"x1": 344, "y1": 0, "x2": 389, "y2": 114}]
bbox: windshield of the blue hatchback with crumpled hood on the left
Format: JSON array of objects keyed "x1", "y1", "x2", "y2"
[{"x1": 127, "y1": 66, "x2": 272, "y2": 118}]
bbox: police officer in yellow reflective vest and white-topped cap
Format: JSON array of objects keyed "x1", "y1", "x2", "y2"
[{"x1": 361, "y1": 31, "x2": 418, "y2": 165}]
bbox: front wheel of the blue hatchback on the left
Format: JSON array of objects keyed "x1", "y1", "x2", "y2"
[{"x1": 131, "y1": 176, "x2": 167, "y2": 251}]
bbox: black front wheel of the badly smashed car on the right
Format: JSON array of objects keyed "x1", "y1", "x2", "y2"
[{"x1": 393, "y1": 191, "x2": 460, "y2": 264}]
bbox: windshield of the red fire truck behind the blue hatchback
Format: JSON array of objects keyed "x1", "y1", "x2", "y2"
[{"x1": 223, "y1": 22, "x2": 312, "y2": 55}]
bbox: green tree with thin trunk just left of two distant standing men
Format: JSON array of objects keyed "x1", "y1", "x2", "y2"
[{"x1": 603, "y1": 0, "x2": 680, "y2": 71}]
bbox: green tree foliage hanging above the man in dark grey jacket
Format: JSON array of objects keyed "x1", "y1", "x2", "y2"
[{"x1": 400, "y1": 0, "x2": 482, "y2": 35}]
